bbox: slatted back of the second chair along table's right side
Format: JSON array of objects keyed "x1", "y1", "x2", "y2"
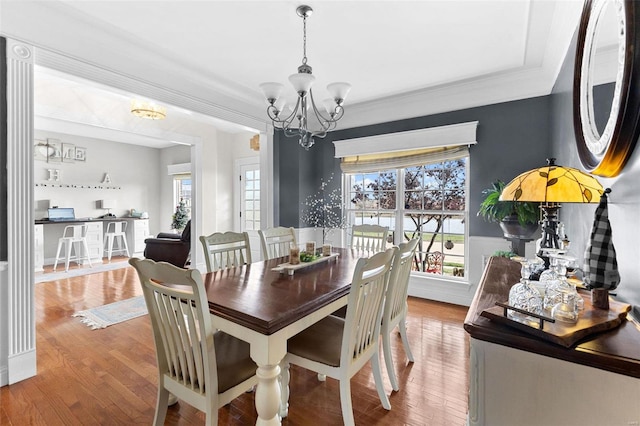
[{"x1": 382, "y1": 238, "x2": 418, "y2": 322}]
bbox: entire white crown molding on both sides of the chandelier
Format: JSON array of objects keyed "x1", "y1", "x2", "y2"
[{"x1": 0, "y1": 1, "x2": 582, "y2": 135}]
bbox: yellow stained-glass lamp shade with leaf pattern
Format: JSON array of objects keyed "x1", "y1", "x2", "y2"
[{"x1": 500, "y1": 158, "x2": 604, "y2": 203}]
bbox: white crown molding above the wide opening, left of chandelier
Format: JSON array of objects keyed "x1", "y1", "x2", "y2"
[{"x1": 0, "y1": 2, "x2": 266, "y2": 131}]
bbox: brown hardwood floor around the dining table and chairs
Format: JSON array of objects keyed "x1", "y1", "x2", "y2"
[{"x1": 0, "y1": 267, "x2": 469, "y2": 426}]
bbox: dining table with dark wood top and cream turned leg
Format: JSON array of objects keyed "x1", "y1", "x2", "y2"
[{"x1": 203, "y1": 248, "x2": 368, "y2": 425}]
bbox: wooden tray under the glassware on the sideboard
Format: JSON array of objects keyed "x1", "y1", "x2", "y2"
[{"x1": 480, "y1": 293, "x2": 631, "y2": 348}]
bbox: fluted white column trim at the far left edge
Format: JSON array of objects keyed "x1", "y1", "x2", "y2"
[{"x1": 3, "y1": 39, "x2": 36, "y2": 384}]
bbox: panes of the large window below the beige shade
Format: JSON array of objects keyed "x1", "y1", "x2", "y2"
[{"x1": 344, "y1": 156, "x2": 468, "y2": 277}]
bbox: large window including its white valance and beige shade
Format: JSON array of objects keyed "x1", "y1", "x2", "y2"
[{"x1": 333, "y1": 121, "x2": 478, "y2": 277}]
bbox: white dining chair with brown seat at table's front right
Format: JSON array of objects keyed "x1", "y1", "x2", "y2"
[{"x1": 280, "y1": 247, "x2": 398, "y2": 426}]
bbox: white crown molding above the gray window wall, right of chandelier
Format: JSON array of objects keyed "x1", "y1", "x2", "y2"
[{"x1": 338, "y1": 1, "x2": 582, "y2": 130}]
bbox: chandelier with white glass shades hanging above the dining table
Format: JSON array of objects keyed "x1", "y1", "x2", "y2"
[{"x1": 260, "y1": 5, "x2": 351, "y2": 150}]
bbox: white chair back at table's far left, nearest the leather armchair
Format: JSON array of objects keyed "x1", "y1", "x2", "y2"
[{"x1": 200, "y1": 231, "x2": 251, "y2": 272}]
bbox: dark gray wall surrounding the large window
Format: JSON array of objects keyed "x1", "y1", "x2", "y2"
[{"x1": 274, "y1": 96, "x2": 551, "y2": 237}]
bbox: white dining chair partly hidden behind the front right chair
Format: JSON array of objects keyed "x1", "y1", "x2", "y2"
[{"x1": 381, "y1": 238, "x2": 418, "y2": 391}]
